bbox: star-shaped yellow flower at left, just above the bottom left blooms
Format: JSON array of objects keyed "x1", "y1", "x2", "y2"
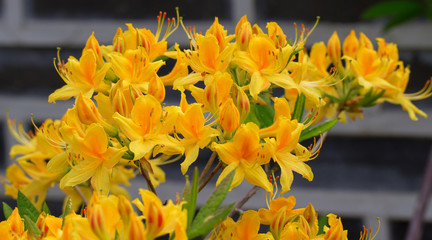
[{"x1": 60, "y1": 123, "x2": 127, "y2": 195}]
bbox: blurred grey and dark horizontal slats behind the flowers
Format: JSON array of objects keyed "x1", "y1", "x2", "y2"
[{"x1": 0, "y1": 0, "x2": 432, "y2": 240}]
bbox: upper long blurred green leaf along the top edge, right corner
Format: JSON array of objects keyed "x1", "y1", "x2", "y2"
[{"x1": 361, "y1": 1, "x2": 422, "y2": 20}]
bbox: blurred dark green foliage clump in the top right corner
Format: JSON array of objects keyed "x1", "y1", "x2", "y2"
[{"x1": 361, "y1": 0, "x2": 432, "y2": 31}]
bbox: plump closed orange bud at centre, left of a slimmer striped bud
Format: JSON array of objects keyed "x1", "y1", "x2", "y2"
[{"x1": 219, "y1": 98, "x2": 240, "y2": 133}]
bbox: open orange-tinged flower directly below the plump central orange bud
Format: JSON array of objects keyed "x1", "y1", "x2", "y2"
[{"x1": 212, "y1": 122, "x2": 272, "y2": 192}]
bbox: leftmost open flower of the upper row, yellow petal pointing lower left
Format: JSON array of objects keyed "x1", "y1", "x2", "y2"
[{"x1": 48, "y1": 49, "x2": 111, "y2": 103}]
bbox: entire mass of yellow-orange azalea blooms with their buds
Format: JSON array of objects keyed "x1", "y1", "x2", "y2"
[{"x1": 2, "y1": 10, "x2": 432, "y2": 239}]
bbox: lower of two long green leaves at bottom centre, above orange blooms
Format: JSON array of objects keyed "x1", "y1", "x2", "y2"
[{"x1": 188, "y1": 202, "x2": 235, "y2": 239}]
